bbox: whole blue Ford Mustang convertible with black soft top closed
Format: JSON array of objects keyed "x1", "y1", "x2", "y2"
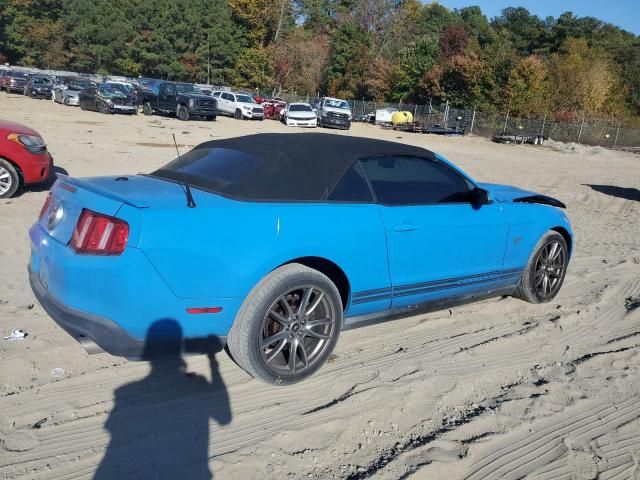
[{"x1": 29, "y1": 133, "x2": 573, "y2": 384}]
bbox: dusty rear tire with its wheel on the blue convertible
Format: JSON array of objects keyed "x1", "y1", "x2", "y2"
[{"x1": 227, "y1": 263, "x2": 342, "y2": 385}]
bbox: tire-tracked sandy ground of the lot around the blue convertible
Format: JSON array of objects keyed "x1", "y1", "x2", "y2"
[{"x1": 0, "y1": 94, "x2": 640, "y2": 480}]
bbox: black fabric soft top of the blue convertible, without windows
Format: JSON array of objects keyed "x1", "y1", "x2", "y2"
[{"x1": 185, "y1": 133, "x2": 435, "y2": 201}]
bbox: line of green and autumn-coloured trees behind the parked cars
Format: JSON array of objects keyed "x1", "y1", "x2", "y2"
[{"x1": 0, "y1": 0, "x2": 640, "y2": 117}]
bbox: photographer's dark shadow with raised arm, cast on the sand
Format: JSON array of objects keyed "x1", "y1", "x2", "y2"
[{"x1": 95, "y1": 320, "x2": 231, "y2": 480}]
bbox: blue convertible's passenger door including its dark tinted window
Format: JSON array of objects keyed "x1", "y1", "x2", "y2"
[{"x1": 362, "y1": 157, "x2": 512, "y2": 309}]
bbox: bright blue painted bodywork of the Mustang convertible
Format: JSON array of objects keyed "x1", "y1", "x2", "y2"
[{"x1": 29, "y1": 157, "x2": 572, "y2": 352}]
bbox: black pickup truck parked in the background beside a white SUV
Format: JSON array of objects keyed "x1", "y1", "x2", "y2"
[{"x1": 140, "y1": 82, "x2": 218, "y2": 121}]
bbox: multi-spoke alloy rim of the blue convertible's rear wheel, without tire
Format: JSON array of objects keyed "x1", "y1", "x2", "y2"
[{"x1": 259, "y1": 285, "x2": 337, "y2": 376}]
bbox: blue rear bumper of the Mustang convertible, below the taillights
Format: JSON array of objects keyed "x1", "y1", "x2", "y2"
[{"x1": 29, "y1": 221, "x2": 235, "y2": 358}]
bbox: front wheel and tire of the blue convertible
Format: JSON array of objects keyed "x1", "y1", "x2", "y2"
[{"x1": 514, "y1": 230, "x2": 569, "y2": 303}]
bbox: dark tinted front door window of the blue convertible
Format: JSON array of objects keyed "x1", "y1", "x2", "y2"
[{"x1": 362, "y1": 157, "x2": 470, "y2": 205}]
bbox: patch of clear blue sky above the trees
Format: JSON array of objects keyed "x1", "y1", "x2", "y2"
[{"x1": 438, "y1": 0, "x2": 640, "y2": 35}]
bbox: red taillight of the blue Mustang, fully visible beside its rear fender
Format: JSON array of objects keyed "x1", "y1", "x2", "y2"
[{"x1": 69, "y1": 209, "x2": 129, "y2": 255}]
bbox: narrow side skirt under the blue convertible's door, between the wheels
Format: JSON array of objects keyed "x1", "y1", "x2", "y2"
[{"x1": 342, "y1": 285, "x2": 516, "y2": 330}]
